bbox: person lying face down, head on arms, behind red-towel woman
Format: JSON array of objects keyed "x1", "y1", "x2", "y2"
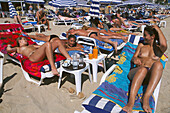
[{"x1": 29, "y1": 33, "x2": 84, "y2": 51}]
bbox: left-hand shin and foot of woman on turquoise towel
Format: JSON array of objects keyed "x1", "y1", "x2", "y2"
[{"x1": 122, "y1": 67, "x2": 148, "y2": 113}]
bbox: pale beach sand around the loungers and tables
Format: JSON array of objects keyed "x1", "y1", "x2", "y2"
[{"x1": 0, "y1": 18, "x2": 170, "y2": 113}]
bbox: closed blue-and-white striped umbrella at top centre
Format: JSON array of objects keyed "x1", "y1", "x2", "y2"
[{"x1": 89, "y1": 0, "x2": 100, "y2": 17}]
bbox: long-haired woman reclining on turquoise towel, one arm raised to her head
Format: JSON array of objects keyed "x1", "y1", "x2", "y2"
[{"x1": 123, "y1": 25, "x2": 167, "y2": 113}]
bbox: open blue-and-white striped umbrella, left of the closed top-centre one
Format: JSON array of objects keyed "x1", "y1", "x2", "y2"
[{"x1": 48, "y1": 0, "x2": 77, "y2": 7}]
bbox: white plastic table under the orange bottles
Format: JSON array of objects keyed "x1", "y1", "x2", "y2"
[{"x1": 84, "y1": 54, "x2": 106, "y2": 82}]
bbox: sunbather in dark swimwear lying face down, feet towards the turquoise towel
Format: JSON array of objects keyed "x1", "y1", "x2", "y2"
[{"x1": 67, "y1": 28, "x2": 126, "y2": 53}]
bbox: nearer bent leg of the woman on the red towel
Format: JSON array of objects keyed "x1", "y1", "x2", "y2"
[{"x1": 29, "y1": 42, "x2": 59, "y2": 76}]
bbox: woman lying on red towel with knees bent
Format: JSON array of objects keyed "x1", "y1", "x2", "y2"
[{"x1": 7, "y1": 37, "x2": 72, "y2": 76}]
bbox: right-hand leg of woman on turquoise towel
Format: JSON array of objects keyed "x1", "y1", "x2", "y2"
[{"x1": 143, "y1": 61, "x2": 163, "y2": 113}]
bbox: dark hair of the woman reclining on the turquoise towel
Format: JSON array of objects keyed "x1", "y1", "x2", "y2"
[{"x1": 144, "y1": 26, "x2": 160, "y2": 44}]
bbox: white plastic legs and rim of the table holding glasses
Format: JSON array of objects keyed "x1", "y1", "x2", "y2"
[{"x1": 58, "y1": 63, "x2": 92, "y2": 95}]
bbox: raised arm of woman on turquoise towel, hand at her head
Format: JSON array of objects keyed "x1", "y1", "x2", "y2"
[{"x1": 153, "y1": 25, "x2": 167, "y2": 53}]
